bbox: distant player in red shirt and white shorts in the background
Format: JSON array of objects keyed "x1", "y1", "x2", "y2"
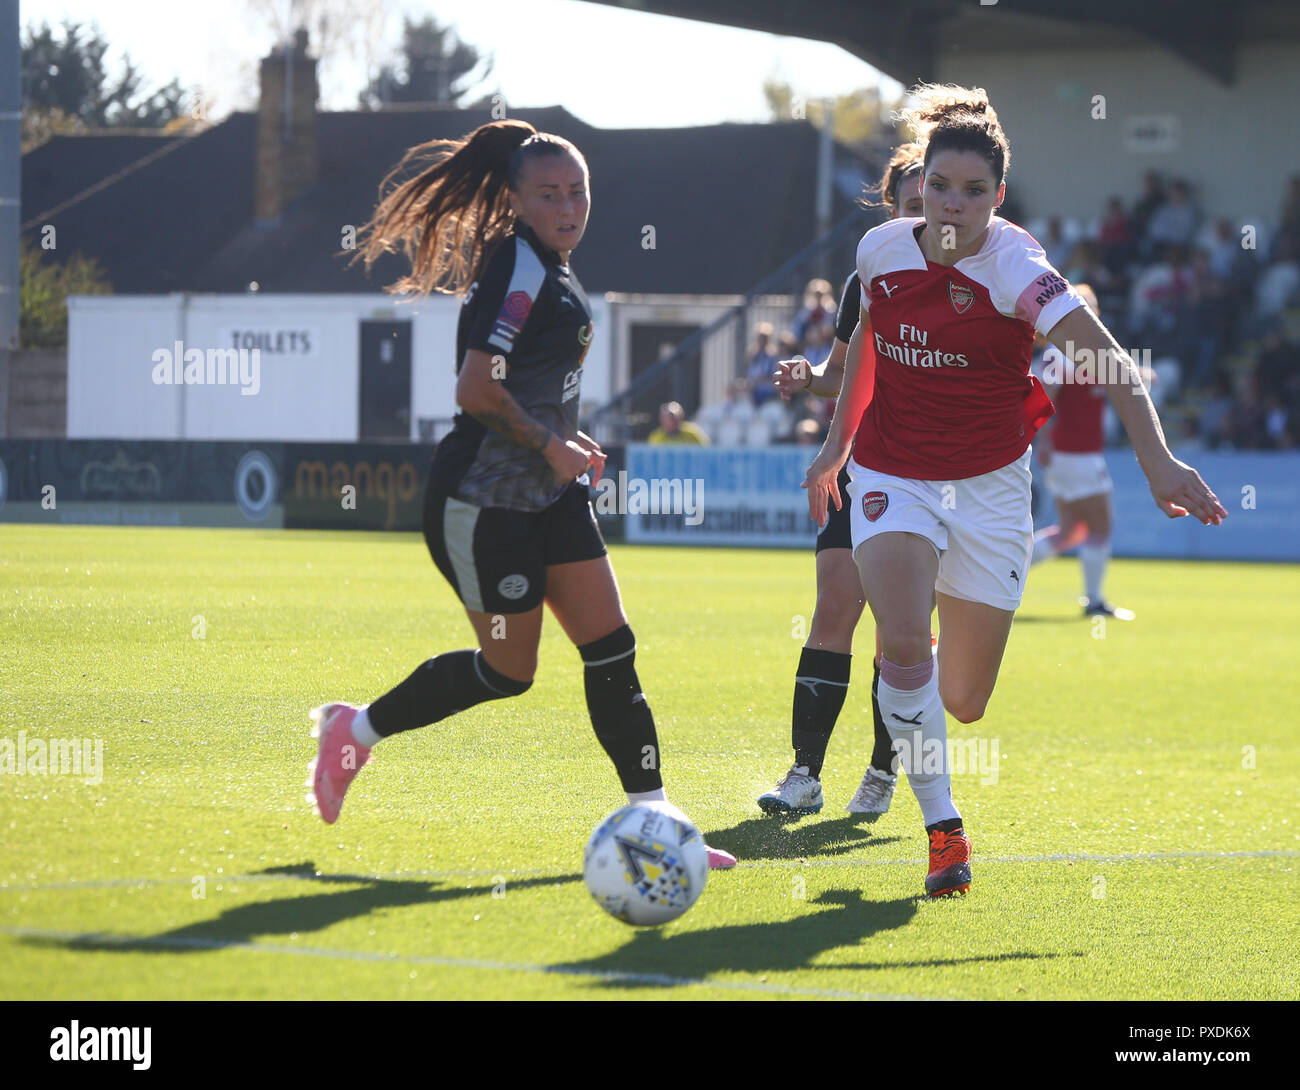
[{"x1": 1030, "y1": 284, "x2": 1133, "y2": 620}]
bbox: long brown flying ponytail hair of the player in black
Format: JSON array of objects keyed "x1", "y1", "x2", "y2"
[{"x1": 352, "y1": 121, "x2": 585, "y2": 295}]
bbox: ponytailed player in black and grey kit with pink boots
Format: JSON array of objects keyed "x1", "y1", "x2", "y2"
[{"x1": 302, "y1": 121, "x2": 736, "y2": 866}]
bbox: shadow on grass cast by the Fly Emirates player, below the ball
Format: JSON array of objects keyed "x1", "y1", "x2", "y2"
[{"x1": 550, "y1": 890, "x2": 920, "y2": 987}]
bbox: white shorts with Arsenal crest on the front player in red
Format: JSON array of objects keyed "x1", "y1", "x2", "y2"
[{"x1": 849, "y1": 450, "x2": 1034, "y2": 610}]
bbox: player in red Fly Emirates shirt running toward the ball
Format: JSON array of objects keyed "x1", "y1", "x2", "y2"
[{"x1": 803, "y1": 85, "x2": 1227, "y2": 896}]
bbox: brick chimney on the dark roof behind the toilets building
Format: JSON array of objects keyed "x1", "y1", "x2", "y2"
[{"x1": 254, "y1": 27, "x2": 320, "y2": 222}]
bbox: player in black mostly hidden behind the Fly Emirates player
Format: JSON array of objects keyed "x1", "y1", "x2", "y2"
[{"x1": 758, "y1": 144, "x2": 924, "y2": 814}]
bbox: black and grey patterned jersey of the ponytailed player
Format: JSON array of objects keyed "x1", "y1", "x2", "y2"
[{"x1": 433, "y1": 224, "x2": 593, "y2": 511}]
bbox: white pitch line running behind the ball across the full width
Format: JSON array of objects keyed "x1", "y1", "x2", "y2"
[{"x1": 0, "y1": 849, "x2": 1300, "y2": 894}]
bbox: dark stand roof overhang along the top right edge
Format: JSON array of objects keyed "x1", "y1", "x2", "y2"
[{"x1": 577, "y1": 0, "x2": 1300, "y2": 85}]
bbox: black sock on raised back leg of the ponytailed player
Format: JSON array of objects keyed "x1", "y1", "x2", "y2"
[{"x1": 369, "y1": 650, "x2": 533, "y2": 738}]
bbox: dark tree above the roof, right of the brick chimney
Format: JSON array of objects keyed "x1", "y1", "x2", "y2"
[{"x1": 360, "y1": 16, "x2": 493, "y2": 109}]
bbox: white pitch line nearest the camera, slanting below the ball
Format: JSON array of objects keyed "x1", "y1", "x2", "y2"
[{"x1": 0, "y1": 927, "x2": 931, "y2": 1002}]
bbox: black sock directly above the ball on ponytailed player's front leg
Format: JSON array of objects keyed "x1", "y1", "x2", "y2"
[{"x1": 579, "y1": 624, "x2": 663, "y2": 792}]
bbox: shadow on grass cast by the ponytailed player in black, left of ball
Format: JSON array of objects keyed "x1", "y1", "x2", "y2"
[{"x1": 19, "y1": 862, "x2": 582, "y2": 953}]
